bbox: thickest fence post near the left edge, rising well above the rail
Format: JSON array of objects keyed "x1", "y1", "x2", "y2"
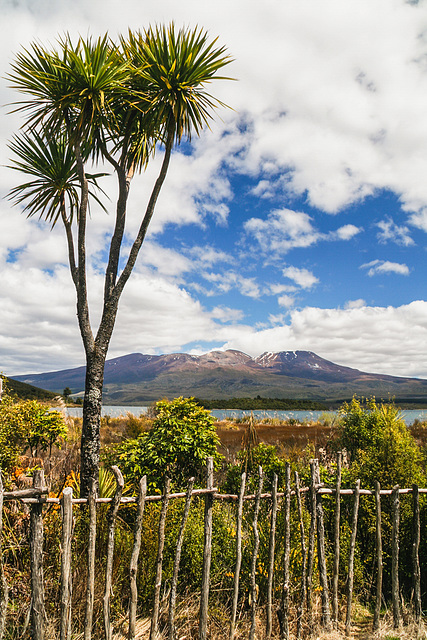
[{"x1": 30, "y1": 469, "x2": 46, "y2": 640}]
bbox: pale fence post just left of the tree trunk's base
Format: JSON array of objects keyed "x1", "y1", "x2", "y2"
[{"x1": 59, "y1": 487, "x2": 73, "y2": 640}]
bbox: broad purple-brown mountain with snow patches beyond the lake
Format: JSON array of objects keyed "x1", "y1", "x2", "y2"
[{"x1": 10, "y1": 350, "x2": 427, "y2": 404}]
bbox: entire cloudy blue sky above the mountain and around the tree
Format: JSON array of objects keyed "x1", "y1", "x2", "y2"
[{"x1": 0, "y1": 0, "x2": 427, "y2": 377}]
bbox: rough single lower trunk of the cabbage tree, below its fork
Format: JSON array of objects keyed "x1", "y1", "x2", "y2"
[{"x1": 80, "y1": 348, "x2": 107, "y2": 498}]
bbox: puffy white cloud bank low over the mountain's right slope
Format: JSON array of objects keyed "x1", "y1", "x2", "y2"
[{"x1": 225, "y1": 300, "x2": 427, "y2": 378}]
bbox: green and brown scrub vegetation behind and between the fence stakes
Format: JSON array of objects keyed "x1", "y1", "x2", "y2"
[{"x1": 0, "y1": 391, "x2": 427, "y2": 640}]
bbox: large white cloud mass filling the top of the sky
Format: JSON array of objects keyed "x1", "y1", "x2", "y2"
[{"x1": 0, "y1": 0, "x2": 427, "y2": 228}]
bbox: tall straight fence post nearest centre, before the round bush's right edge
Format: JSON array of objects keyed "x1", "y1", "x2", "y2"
[{"x1": 199, "y1": 457, "x2": 213, "y2": 640}]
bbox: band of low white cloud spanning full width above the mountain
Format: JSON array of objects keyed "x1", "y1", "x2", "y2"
[{"x1": 0, "y1": 254, "x2": 427, "y2": 377}]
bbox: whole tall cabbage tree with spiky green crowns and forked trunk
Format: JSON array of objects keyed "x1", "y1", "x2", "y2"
[{"x1": 9, "y1": 24, "x2": 230, "y2": 495}]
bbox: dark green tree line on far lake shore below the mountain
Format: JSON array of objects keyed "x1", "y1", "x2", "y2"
[{"x1": 195, "y1": 396, "x2": 328, "y2": 411}]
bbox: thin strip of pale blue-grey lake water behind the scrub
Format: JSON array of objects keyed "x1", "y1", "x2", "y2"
[{"x1": 64, "y1": 406, "x2": 427, "y2": 425}]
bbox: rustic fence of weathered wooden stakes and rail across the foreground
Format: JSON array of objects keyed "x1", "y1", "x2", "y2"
[{"x1": 0, "y1": 453, "x2": 427, "y2": 640}]
